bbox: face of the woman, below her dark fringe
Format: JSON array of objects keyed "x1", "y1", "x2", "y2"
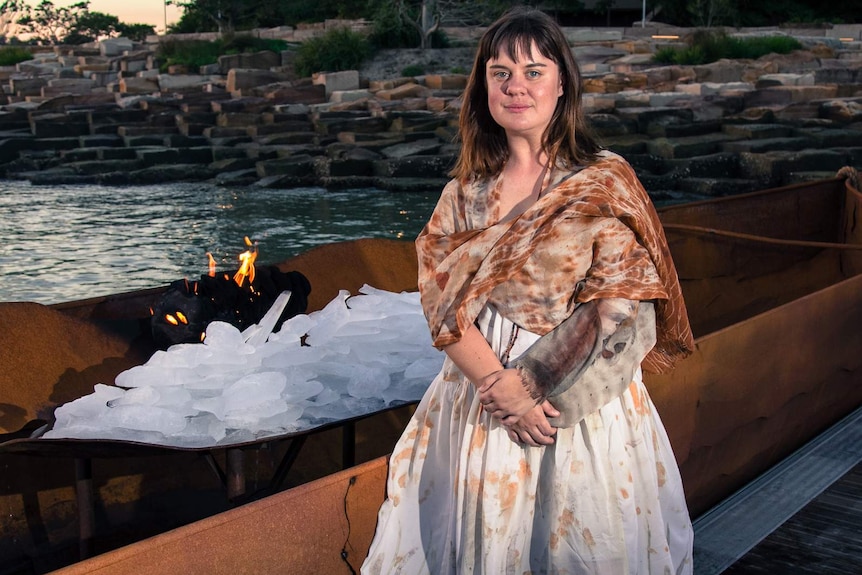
[{"x1": 485, "y1": 43, "x2": 563, "y2": 141}]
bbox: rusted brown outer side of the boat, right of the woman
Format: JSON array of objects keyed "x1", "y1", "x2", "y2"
[{"x1": 647, "y1": 275, "x2": 862, "y2": 516}]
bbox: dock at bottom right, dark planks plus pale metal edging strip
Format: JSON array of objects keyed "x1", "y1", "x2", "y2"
[{"x1": 694, "y1": 407, "x2": 862, "y2": 575}]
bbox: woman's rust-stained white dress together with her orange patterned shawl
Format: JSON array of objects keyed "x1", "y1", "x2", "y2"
[{"x1": 362, "y1": 152, "x2": 693, "y2": 575}]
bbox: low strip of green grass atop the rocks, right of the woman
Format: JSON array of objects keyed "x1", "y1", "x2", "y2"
[{"x1": 653, "y1": 30, "x2": 802, "y2": 65}]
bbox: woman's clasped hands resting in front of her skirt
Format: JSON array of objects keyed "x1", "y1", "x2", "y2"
[{"x1": 478, "y1": 368, "x2": 560, "y2": 447}]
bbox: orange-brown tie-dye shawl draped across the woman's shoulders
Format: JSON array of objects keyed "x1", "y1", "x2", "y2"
[{"x1": 416, "y1": 152, "x2": 694, "y2": 373}]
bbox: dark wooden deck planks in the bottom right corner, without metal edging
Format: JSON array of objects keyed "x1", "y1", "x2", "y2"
[{"x1": 723, "y1": 463, "x2": 862, "y2": 575}]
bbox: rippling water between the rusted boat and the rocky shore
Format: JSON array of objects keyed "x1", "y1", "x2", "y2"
[{"x1": 0, "y1": 180, "x2": 439, "y2": 304}]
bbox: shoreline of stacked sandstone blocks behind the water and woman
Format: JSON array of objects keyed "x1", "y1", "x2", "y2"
[{"x1": 0, "y1": 26, "x2": 862, "y2": 205}]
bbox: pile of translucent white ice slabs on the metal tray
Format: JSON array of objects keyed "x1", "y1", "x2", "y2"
[{"x1": 42, "y1": 285, "x2": 443, "y2": 447}]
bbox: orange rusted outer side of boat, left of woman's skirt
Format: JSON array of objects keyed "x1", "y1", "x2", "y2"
[{"x1": 49, "y1": 458, "x2": 387, "y2": 575}]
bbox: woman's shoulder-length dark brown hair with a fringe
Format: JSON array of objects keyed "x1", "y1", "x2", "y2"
[{"x1": 450, "y1": 6, "x2": 600, "y2": 180}]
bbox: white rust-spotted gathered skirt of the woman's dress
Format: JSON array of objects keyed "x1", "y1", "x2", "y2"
[{"x1": 362, "y1": 306, "x2": 693, "y2": 575}]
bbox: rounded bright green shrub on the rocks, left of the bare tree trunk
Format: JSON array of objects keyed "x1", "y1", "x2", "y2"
[{"x1": 294, "y1": 28, "x2": 371, "y2": 77}]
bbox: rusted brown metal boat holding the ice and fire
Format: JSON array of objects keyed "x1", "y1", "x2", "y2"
[{"x1": 0, "y1": 173, "x2": 862, "y2": 574}]
